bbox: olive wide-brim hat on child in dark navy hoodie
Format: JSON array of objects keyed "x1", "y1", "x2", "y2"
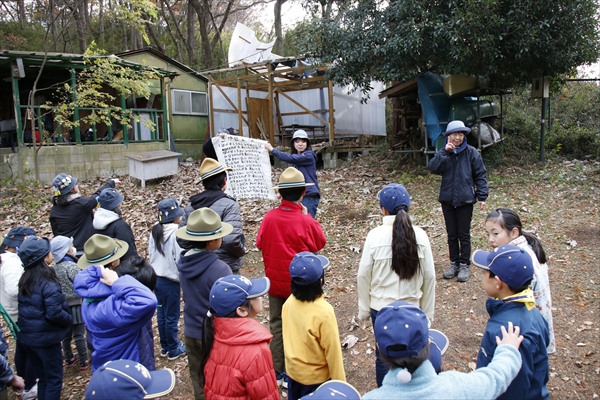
[{"x1": 175, "y1": 207, "x2": 233, "y2": 242}]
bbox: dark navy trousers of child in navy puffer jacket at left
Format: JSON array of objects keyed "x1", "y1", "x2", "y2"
[{"x1": 23, "y1": 343, "x2": 63, "y2": 400}]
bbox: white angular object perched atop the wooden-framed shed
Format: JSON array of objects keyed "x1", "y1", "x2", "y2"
[{"x1": 228, "y1": 22, "x2": 278, "y2": 68}]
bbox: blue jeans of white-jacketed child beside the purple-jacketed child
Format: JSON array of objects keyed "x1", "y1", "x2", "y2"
[{"x1": 154, "y1": 276, "x2": 181, "y2": 355}]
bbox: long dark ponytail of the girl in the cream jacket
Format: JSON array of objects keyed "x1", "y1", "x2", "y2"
[{"x1": 392, "y1": 210, "x2": 421, "y2": 280}]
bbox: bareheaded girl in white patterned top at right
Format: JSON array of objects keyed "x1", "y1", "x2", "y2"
[{"x1": 485, "y1": 208, "x2": 556, "y2": 354}]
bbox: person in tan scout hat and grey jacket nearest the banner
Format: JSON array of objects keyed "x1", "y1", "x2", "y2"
[{"x1": 178, "y1": 158, "x2": 246, "y2": 273}]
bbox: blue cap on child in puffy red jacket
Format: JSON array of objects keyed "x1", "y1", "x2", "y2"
[{"x1": 209, "y1": 275, "x2": 271, "y2": 317}]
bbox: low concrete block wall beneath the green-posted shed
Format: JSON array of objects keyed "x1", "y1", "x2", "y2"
[{"x1": 0, "y1": 142, "x2": 169, "y2": 185}]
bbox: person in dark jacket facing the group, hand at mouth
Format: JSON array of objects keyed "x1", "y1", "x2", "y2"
[{"x1": 429, "y1": 121, "x2": 488, "y2": 282}]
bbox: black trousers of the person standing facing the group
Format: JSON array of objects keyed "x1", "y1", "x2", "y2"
[{"x1": 442, "y1": 203, "x2": 473, "y2": 265}]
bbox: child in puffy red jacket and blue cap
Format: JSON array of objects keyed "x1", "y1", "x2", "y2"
[{"x1": 200, "y1": 275, "x2": 279, "y2": 400}]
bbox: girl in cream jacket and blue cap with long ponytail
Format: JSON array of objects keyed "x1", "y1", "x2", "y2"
[{"x1": 358, "y1": 183, "x2": 435, "y2": 387}]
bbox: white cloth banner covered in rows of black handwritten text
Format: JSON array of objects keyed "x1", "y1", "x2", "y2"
[{"x1": 211, "y1": 135, "x2": 277, "y2": 200}]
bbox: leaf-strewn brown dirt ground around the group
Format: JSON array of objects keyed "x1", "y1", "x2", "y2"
[{"x1": 0, "y1": 153, "x2": 600, "y2": 399}]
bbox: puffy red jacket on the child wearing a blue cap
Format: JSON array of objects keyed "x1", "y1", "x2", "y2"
[{"x1": 204, "y1": 317, "x2": 279, "y2": 400}]
